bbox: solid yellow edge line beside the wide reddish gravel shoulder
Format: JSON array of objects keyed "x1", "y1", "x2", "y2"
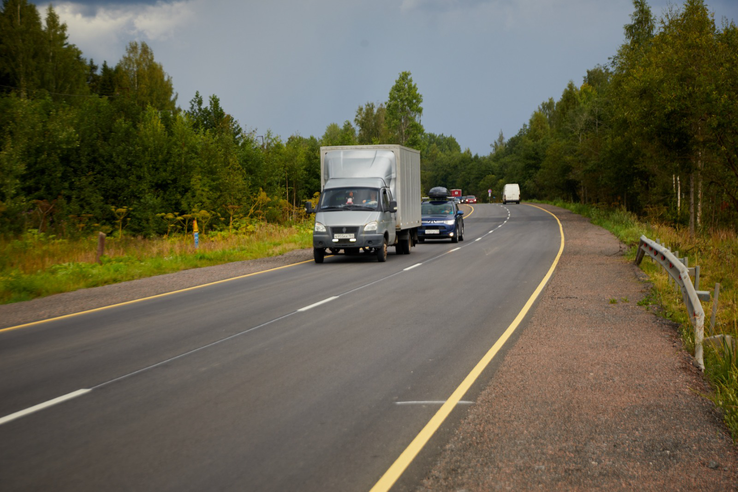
[{"x1": 371, "y1": 205, "x2": 564, "y2": 492}]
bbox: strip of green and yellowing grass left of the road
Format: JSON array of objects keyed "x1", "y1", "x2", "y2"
[{"x1": 0, "y1": 224, "x2": 312, "y2": 304}]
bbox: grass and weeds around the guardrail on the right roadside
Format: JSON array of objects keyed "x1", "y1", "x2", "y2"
[{"x1": 551, "y1": 201, "x2": 738, "y2": 440}]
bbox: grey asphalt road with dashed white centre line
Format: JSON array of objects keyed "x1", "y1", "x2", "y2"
[{"x1": 0, "y1": 204, "x2": 561, "y2": 491}]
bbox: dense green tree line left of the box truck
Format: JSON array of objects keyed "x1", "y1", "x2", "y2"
[{"x1": 0, "y1": 0, "x2": 319, "y2": 235}]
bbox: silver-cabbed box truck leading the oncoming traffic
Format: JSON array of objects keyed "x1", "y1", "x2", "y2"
[{"x1": 306, "y1": 145, "x2": 422, "y2": 263}]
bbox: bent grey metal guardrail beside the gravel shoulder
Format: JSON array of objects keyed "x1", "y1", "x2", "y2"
[{"x1": 635, "y1": 236, "x2": 710, "y2": 371}]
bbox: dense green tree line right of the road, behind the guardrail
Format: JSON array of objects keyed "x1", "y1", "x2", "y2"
[{"x1": 484, "y1": 0, "x2": 738, "y2": 233}]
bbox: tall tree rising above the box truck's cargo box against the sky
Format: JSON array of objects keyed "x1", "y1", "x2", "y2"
[{"x1": 386, "y1": 72, "x2": 425, "y2": 149}]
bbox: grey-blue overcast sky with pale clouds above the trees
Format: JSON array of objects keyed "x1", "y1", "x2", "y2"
[{"x1": 37, "y1": 0, "x2": 738, "y2": 155}]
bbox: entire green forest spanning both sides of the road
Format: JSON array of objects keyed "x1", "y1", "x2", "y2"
[{"x1": 0, "y1": 0, "x2": 738, "y2": 237}]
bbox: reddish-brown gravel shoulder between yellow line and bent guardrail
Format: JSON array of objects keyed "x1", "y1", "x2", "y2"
[{"x1": 419, "y1": 206, "x2": 738, "y2": 491}]
